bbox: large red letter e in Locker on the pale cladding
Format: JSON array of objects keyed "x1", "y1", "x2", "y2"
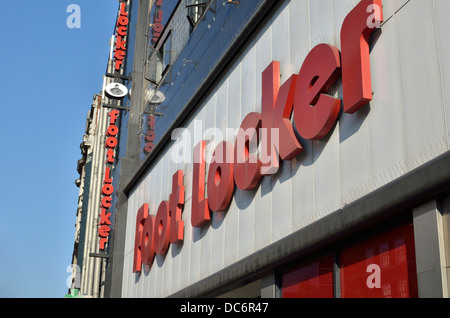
[{"x1": 294, "y1": 44, "x2": 341, "y2": 139}]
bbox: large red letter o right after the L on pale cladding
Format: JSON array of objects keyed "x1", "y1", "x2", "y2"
[{"x1": 208, "y1": 141, "x2": 234, "y2": 212}]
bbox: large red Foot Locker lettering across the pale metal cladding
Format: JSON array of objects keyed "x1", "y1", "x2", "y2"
[{"x1": 133, "y1": 0, "x2": 383, "y2": 273}]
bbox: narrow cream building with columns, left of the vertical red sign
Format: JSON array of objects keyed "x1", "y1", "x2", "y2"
[{"x1": 71, "y1": 94, "x2": 107, "y2": 298}]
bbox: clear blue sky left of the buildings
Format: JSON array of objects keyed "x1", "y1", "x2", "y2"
[{"x1": 0, "y1": 0, "x2": 118, "y2": 298}]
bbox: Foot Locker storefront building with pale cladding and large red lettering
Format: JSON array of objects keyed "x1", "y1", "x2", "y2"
[{"x1": 70, "y1": 0, "x2": 450, "y2": 298}]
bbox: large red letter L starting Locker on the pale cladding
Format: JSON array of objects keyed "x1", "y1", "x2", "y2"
[{"x1": 191, "y1": 141, "x2": 211, "y2": 227}]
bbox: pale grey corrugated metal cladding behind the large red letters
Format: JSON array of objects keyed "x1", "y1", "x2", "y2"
[{"x1": 118, "y1": 0, "x2": 450, "y2": 297}]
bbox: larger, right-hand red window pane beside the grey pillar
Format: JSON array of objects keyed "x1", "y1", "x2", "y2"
[{"x1": 340, "y1": 224, "x2": 418, "y2": 298}]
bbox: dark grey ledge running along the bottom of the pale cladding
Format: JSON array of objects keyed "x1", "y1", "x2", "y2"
[{"x1": 171, "y1": 152, "x2": 450, "y2": 297}]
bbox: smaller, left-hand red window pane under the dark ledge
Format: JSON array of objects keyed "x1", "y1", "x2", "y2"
[{"x1": 282, "y1": 255, "x2": 333, "y2": 298}]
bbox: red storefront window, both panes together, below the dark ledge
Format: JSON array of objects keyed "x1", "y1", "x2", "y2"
[{"x1": 282, "y1": 223, "x2": 418, "y2": 298}]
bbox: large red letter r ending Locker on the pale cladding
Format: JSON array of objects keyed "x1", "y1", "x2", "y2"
[{"x1": 341, "y1": 0, "x2": 383, "y2": 114}]
